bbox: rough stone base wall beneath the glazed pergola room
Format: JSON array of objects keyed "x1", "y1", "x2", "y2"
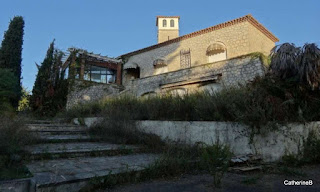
[{"x1": 66, "y1": 80, "x2": 124, "y2": 109}]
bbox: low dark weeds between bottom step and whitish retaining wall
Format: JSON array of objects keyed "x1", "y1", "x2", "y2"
[{"x1": 81, "y1": 144, "x2": 231, "y2": 192}]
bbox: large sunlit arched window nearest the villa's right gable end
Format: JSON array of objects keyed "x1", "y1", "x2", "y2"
[{"x1": 206, "y1": 42, "x2": 227, "y2": 63}]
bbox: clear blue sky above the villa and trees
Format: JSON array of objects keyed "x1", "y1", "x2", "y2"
[{"x1": 0, "y1": 0, "x2": 320, "y2": 90}]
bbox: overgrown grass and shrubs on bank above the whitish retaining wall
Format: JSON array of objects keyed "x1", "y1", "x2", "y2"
[{"x1": 67, "y1": 44, "x2": 320, "y2": 132}]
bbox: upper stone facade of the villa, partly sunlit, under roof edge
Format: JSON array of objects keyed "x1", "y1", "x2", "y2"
[{"x1": 123, "y1": 21, "x2": 275, "y2": 85}]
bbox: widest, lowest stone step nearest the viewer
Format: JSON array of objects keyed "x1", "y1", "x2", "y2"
[{"x1": 27, "y1": 154, "x2": 159, "y2": 192}]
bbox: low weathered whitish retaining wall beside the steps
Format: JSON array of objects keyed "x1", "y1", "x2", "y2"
[{"x1": 76, "y1": 118, "x2": 320, "y2": 162}]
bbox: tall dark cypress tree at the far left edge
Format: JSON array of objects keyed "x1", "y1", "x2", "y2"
[{"x1": 0, "y1": 16, "x2": 24, "y2": 108}]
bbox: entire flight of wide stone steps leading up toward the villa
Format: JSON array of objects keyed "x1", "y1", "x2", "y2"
[{"x1": 25, "y1": 121, "x2": 159, "y2": 192}]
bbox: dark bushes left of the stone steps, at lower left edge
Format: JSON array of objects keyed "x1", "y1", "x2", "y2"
[{"x1": 0, "y1": 116, "x2": 35, "y2": 180}]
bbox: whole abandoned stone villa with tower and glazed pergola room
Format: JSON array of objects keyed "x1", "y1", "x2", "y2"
[{"x1": 64, "y1": 15, "x2": 279, "y2": 108}]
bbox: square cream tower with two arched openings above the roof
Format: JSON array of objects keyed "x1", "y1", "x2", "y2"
[{"x1": 156, "y1": 16, "x2": 180, "y2": 43}]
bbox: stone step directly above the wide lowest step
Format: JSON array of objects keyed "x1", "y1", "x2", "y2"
[{"x1": 25, "y1": 142, "x2": 143, "y2": 160}]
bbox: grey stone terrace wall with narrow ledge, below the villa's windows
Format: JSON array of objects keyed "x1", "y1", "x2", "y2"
[{"x1": 126, "y1": 54, "x2": 265, "y2": 96}]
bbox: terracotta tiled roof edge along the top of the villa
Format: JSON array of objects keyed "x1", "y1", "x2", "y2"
[{"x1": 119, "y1": 14, "x2": 279, "y2": 57}]
